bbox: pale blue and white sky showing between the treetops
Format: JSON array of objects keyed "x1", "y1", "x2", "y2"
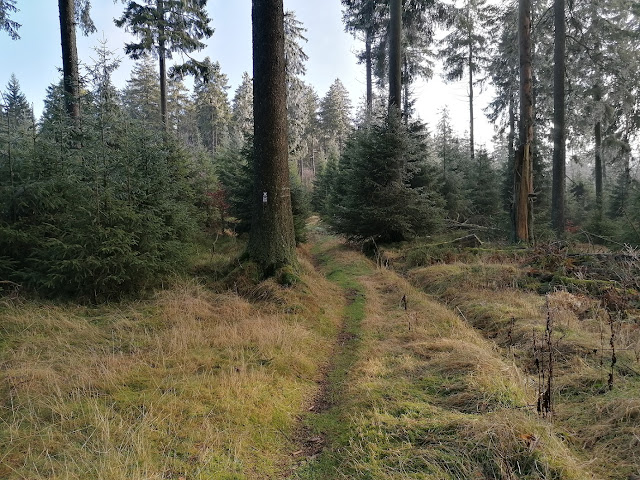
[{"x1": 0, "y1": 0, "x2": 493, "y2": 149}]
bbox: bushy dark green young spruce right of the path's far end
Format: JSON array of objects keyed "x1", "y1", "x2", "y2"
[{"x1": 317, "y1": 115, "x2": 442, "y2": 241}]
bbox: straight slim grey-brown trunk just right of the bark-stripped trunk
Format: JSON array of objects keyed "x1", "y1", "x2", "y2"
[{"x1": 551, "y1": 0, "x2": 566, "y2": 236}]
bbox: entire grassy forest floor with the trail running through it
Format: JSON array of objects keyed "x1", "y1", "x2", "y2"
[{"x1": 0, "y1": 220, "x2": 640, "y2": 480}]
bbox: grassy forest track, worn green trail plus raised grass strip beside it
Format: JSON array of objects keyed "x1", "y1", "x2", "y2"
[{"x1": 284, "y1": 224, "x2": 598, "y2": 480}]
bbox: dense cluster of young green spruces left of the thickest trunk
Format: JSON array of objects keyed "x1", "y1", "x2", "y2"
[{"x1": 0, "y1": 63, "x2": 214, "y2": 300}]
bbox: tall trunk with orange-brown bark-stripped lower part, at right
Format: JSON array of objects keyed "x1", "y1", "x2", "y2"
[{"x1": 514, "y1": 0, "x2": 533, "y2": 242}]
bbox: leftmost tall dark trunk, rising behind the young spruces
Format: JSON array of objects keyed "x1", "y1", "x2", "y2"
[{"x1": 58, "y1": 0, "x2": 80, "y2": 120}]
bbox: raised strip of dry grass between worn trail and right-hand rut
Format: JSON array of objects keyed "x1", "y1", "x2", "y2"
[{"x1": 296, "y1": 260, "x2": 598, "y2": 480}]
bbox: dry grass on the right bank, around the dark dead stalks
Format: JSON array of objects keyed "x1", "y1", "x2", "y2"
[{"x1": 408, "y1": 253, "x2": 640, "y2": 479}]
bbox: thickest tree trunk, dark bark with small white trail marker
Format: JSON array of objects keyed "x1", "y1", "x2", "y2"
[{"x1": 247, "y1": 0, "x2": 296, "y2": 275}]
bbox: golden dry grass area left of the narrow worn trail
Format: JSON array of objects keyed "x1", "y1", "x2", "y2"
[{"x1": 0, "y1": 249, "x2": 342, "y2": 480}]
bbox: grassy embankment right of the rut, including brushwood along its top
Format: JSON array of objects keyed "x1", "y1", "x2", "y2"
[{"x1": 390, "y1": 240, "x2": 640, "y2": 479}]
